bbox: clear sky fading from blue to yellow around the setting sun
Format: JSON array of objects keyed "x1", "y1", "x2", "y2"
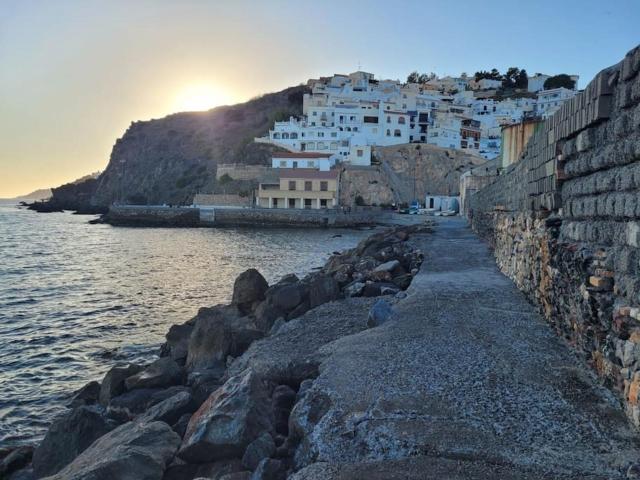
[{"x1": 0, "y1": 0, "x2": 640, "y2": 197}]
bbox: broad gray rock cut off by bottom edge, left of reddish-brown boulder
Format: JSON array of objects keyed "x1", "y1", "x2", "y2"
[{"x1": 48, "y1": 422, "x2": 180, "y2": 480}]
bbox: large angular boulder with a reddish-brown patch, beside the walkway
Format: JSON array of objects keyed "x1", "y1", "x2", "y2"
[{"x1": 178, "y1": 370, "x2": 273, "y2": 463}]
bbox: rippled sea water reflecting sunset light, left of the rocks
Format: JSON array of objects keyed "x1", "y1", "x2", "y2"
[{"x1": 0, "y1": 205, "x2": 370, "y2": 446}]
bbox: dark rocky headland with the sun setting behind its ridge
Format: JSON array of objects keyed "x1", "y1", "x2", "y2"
[{"x1": 91, "y1": 86, "x2": 306, "y2": 206}]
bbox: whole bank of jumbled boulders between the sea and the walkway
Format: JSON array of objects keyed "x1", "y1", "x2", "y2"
[{"x1": 0, "y1": 224, "x2": 431, "y2": 480}]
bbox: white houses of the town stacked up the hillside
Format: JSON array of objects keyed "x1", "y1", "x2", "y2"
[{"x1": 256, "y1": 69, "x2": 578, "y2": 165}]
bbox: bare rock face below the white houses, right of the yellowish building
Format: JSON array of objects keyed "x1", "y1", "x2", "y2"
[{"x1": 340, "y1": 144, "x2": 486, "y2": 205}]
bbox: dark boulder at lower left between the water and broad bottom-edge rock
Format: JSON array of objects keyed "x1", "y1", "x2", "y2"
[{"x1": 33, "y1": 406, "x2": 117, "y2": 478}]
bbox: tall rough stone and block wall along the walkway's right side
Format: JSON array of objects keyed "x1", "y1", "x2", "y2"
[{"x1": 467, "y1": 48, "x2": 640, "y2": 427}]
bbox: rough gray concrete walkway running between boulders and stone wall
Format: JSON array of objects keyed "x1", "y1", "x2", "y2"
[{"x1": 294, "y1": 218, "x2": 640, "y2": 480}]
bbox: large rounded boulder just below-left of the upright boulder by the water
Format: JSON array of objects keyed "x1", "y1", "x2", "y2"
[{"x1": 186, "y1": 305, "x2": 264, "y2": 370}]
